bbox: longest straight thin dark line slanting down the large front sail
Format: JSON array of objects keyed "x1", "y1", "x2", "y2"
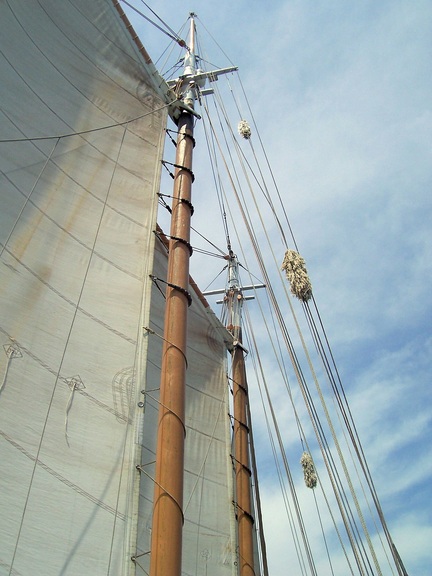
[{"x1": 10, "y1": 127, "x2": 126, "y2": 570}]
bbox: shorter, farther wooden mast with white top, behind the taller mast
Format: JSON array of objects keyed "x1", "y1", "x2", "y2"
[{"x1": 226, "y1": 251, "x2": 255, "y2": 576}]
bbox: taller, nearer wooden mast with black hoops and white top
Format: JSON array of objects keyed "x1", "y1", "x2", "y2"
[{"x1": 150, "y1": 13, "x2": 195, "y2": 576}]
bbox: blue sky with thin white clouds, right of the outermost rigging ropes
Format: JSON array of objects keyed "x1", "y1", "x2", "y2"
[{"x1": 123, "y1": 0, "x2": 432, "y2": 576}]
